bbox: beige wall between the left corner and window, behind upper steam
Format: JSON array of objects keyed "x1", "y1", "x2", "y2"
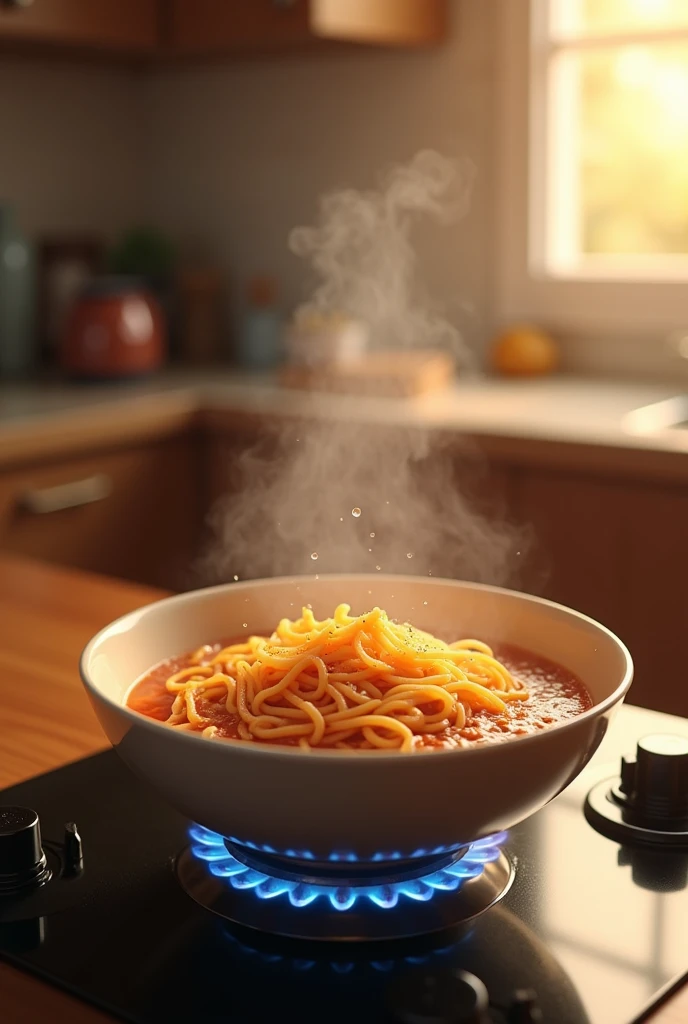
[{"x1": 145, "y1": 0, "x2": 495, "y2": 360}]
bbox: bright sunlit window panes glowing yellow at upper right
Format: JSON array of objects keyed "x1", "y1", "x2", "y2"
[{"x1": 531, "y1": 0, "x2": 688, "y2": 276}]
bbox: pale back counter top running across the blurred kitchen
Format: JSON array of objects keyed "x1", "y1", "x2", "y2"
[{"x1": 0, "y1": 370, "x2": 688, "y2": 479}]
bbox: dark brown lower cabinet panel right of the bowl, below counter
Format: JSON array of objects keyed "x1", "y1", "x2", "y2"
[{"x1": 513, "y1": 470, "x2": 688, "y2": 716}]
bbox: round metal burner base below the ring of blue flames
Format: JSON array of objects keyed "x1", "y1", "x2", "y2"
[{"x1": 175, "y1": 848, "x2": 514, "y2": 942}]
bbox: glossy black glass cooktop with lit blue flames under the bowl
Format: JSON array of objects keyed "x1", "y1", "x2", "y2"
[{"x1": 0, "y1": 709, "x2": 688, "y2": 1024}]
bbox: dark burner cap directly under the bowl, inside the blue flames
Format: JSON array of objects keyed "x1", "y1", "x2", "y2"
[{"x1": 224, "y1": 839, "x2": 469, "y2": 886}]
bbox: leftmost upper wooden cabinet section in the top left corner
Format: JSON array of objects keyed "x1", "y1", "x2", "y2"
[{"x1": 0, "y1": 0, "x2": 161, "y2": 53}]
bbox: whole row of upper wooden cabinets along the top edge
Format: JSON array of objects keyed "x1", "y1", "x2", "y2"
[{"x1": 0, "y1": 0, "x2": 448, "y2": 58}]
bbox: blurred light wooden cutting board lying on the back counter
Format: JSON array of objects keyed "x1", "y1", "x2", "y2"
[{"x1": 280, "y1": 349, "x2": 456, "y2": 398}]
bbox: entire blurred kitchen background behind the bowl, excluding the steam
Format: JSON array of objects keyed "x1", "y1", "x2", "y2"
[{"x1": 0, "y1": 0, "x2": 688, "y2": 714}]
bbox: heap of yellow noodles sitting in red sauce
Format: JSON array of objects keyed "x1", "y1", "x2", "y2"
[{"x1": 153, "y1": 604, "x2": 528, "y2": 752}]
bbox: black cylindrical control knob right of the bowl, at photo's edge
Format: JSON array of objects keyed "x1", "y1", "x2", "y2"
[{"x1": 620, "y1": 733, "x2": 688, "y2": 825}]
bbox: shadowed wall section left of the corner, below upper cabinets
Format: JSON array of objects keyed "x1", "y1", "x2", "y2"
[{"x1": 0, "y1": 55, "x2": 146, "y2": 237}]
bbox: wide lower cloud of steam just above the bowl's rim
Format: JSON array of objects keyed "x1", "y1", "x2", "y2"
[{"x1": 208, "y1": 421, "x2": 516, "y2": 583}]
